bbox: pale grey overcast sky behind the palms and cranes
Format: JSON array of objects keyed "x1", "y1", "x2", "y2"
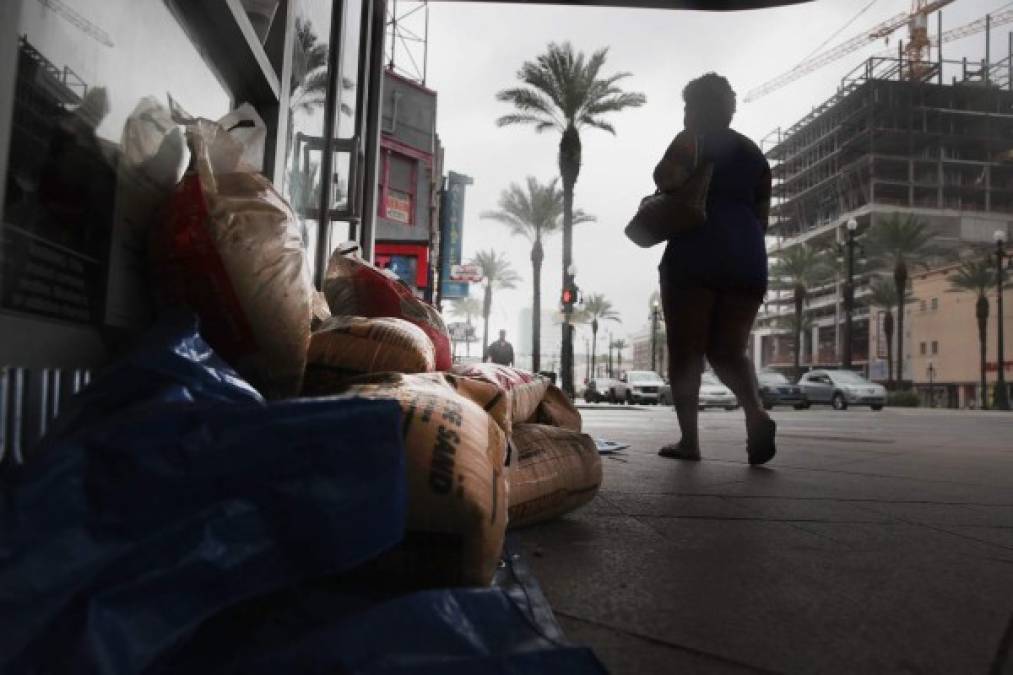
[{"x1": 415, "y1": 0, "x2": 1013, "y2": 352}]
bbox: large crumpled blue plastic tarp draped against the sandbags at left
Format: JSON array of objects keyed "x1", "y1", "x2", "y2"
[{"x1": 0, "y1": 320, "x2": 406, "y2": 673}]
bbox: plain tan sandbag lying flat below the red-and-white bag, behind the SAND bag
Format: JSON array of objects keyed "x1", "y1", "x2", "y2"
[{"x1": 306, "y1": 316, "x2": 436, "y2": 379}]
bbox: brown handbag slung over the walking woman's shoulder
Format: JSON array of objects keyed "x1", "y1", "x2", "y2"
[{"x1": 626, "y1": 137, "x2": 714, "y2": 248}]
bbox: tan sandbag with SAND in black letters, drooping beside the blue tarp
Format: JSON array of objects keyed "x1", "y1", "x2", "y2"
[{"x1": 307, "y1": 373, "x2": 507, "y2": 587}]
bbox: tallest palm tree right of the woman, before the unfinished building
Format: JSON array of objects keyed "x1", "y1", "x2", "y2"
[{"x1": 865, "y1": 213, "x2": 936, "y2": 386}]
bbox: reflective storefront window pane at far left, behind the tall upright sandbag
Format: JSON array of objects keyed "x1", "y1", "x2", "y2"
[{"x1": 0, "y1": 0, "x2": 231, "y2": 325}]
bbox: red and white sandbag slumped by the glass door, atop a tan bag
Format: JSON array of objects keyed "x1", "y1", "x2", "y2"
[{"x1": 323, "y1": 249, "x2": 453, "y2": 371}]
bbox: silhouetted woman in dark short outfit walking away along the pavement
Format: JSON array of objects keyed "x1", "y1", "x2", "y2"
[{"x1": 654, "y1": 73, "x2": 776, "y2": 464}]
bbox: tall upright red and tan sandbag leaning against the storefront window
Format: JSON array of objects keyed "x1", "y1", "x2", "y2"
[{"x1": 151, "y1": 120, "x2": 314, "y2": 397}]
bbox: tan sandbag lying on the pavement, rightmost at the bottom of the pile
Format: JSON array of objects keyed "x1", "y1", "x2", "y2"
[{"x1": 509, "y1": 425, "x2": 602, "y2": 528}]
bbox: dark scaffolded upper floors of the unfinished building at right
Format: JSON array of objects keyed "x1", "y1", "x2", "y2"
[{"x1": 761, "y1": 56, "x2": 1013, "y2": 240}]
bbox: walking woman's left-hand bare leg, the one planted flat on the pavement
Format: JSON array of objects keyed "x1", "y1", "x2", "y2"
[{"x1": 661, "y1": 285, "x2": 715, "y2": 456}]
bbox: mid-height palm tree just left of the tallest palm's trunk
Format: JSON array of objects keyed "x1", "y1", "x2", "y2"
[{"x1": 482, "y1": 176, "x2": 595, "y2": 372}]
